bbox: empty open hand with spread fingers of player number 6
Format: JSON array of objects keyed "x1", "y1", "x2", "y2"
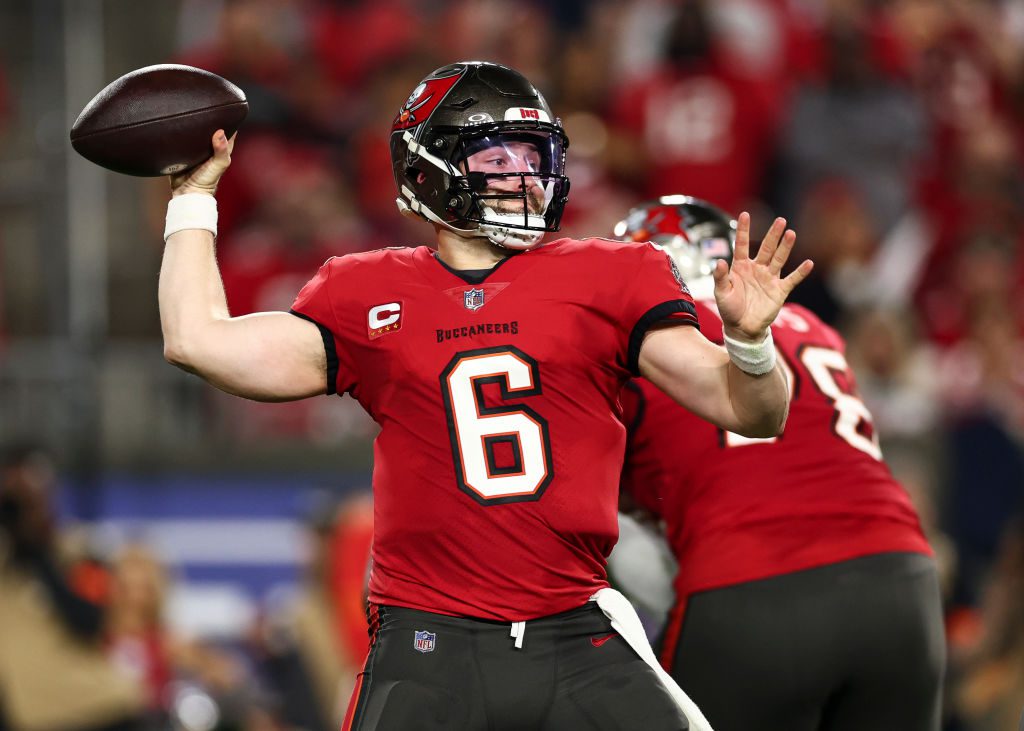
[{"x1": 715, "y1": 212, "x2": 814, "y2": 342}]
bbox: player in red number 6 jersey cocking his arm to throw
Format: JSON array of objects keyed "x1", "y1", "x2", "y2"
[{"x1": 160, "y1": 61, "x2": 811, "y2": 730}]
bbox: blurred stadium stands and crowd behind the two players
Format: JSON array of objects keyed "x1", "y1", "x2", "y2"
[{"x1": 0, "y1": 0, "x2": 1024, "y2": 731}]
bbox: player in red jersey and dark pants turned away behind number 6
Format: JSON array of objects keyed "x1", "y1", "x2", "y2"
[{"x1": 615, "y1": 196, "x2": 944, "y2": 731}]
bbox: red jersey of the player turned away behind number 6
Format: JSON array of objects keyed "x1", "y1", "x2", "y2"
[{"x1": 623, "y1": 301, "x2": 931, "y2": 600}]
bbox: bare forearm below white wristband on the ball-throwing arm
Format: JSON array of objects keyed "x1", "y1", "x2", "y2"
[{"x1": 159, "y1": 228, "x2": 229, "y2": 375}]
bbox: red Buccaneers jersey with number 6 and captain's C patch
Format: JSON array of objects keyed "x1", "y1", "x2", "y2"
[{"x1": 293, "y1": 239, "x2": 696, "y2": 621}]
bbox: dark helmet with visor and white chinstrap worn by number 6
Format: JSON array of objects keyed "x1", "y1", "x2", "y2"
[{"x1": 391, "y1": 61, "x2": 569, "y2": 249}]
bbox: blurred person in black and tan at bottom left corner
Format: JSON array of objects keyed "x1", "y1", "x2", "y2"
[{"x1": 0, "y1": 446, "x2": 144, "y2": 731}]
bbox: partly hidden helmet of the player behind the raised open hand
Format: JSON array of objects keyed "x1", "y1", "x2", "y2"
[{"x1": 614, "y1": 196, "x2": 736, "y2": 298}]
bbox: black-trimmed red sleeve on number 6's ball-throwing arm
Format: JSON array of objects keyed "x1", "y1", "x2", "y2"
[{"x1": 290, "y1": 258, "x2": 356, "y2": 395}]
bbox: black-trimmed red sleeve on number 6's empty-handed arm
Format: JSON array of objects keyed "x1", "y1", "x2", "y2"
[{"x1": 623, "y1": 244, "x2": 700, "y2": 376}]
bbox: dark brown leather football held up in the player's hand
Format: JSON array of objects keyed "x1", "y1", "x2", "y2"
[{"x1": 71, "y1": 63, "x2": 249, "y2": 177}]
